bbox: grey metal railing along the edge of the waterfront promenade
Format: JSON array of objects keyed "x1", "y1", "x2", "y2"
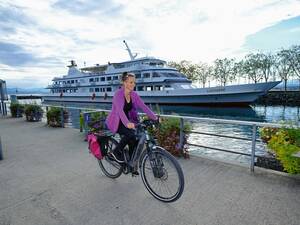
[{"x1": 36, "y1": 104, "x2": 300, "y2": 172}]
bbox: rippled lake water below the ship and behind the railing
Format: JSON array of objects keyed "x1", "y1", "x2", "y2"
[{"x1": 11, "y1": 100, "x2": 300, "y2": 163}]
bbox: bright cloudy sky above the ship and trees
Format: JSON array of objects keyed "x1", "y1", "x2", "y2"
[{"x1": 0, "y1": 0, "x2": 300, "y2": 88}]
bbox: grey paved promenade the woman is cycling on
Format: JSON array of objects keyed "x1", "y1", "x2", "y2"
[{"x1": 0, "y1": 117, "x2": 300, "y2": 225}]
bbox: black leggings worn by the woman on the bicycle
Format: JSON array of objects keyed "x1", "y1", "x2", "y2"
[{"x1": 115, "y1": 121, "x2": 137, "y2": 156}]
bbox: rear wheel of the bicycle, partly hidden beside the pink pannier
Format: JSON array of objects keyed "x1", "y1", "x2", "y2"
[{"x1": 98, "y1": 137, "x2": 122, "y2": 179}]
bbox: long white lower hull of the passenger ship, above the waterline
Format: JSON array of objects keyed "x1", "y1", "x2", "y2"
[{"x1": 43, "y1": 82, "x2": 279, "y2": 106}]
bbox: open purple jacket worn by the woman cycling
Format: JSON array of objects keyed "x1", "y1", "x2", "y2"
[{"x1": 106, "y1": 87, "x2": 157, "y2": 133}]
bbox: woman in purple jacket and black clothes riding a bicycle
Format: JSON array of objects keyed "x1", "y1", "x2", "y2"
[{"x1": 106, "y1": 72, "x2": 157, "y2": 162}]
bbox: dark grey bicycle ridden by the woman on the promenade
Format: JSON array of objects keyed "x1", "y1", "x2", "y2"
[{"x1": 98, "y1": 120, "x2": 184, "y2": 202}]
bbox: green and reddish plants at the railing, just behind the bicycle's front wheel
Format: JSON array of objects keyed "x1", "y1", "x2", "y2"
[{"x1": 150, "y1": 118, "x2": 191, "y2": 158}]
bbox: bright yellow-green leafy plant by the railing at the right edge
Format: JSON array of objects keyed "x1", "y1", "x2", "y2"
[{"x1": 268, "y1": 128, "x2": 300, "y2": 174}]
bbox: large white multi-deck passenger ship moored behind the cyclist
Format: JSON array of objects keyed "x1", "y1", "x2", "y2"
[{"x1": 43, "y1": 41, "x2": 279, "y2": 105}]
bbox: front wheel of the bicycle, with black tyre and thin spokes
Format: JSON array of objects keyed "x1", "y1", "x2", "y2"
[{"x1": 141, "y1": 147, "x2": 184, "y2": 202}]
